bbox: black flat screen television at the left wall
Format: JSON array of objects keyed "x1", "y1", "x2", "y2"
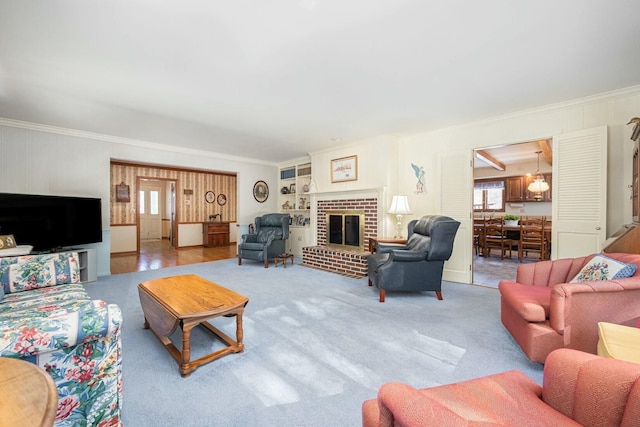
[{"x1": 0, "y1": 193, "x2": 102, "y2": 252}]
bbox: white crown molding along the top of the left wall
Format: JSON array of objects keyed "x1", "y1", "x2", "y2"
[{"x1": 0, "y1": 117, "x2": 277, "y2": 166}]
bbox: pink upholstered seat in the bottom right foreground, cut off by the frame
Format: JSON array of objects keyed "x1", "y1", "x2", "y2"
[{"x1": 362, "y1": 349, "x2": 640, "y2": 427}]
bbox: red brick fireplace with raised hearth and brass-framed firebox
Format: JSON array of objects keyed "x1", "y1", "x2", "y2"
[{"x1": 302, "y1": 197, "x2": 378, "y2": 277}]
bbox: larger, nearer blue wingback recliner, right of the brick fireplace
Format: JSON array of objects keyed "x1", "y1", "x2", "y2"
[{"x1": 367, "y1": 215, "x2": 460, "y2": 302}]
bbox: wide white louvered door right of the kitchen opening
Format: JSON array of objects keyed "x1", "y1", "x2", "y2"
[{"x1": 551, "y1": 126, "x2": 607, "y2": 259}]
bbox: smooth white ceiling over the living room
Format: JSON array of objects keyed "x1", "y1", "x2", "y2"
[{"x1": 0, "y1": 0, "x2": 640, "y2": 161}]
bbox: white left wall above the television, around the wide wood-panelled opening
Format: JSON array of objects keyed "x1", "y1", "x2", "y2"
[{"x1": 0, "y1": 119, "x2": 278, "y2": 275}]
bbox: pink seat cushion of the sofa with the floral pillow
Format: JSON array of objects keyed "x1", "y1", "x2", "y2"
[{"x1": 498, "y1": 280, "x2": 551, "y2": 322}]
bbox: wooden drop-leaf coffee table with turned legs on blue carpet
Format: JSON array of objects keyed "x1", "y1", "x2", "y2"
[{"x1": 138, "y1": 274, "x2": 249, "y2": 377}]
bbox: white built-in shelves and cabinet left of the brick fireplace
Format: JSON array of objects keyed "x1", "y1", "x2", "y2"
[{"x1": 278, "y1": 161, "x2": 312, "y2": 256}]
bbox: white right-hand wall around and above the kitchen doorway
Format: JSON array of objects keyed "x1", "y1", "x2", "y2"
[{"x1": 400, "y1": 87, "x2": 640, "y2": 277}]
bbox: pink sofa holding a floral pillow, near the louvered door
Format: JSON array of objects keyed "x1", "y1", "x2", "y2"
[{"x1": 498, "y1": 253, "x2": 640, "y2": 363}]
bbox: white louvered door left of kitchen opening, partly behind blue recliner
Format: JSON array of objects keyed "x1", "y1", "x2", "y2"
[{"x1": 440, "y1": 150, "x2": 473, "y2": 283}]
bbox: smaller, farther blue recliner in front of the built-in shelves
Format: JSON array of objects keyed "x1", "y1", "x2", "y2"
[{"x1": 238, "y1": 214, "x2": 289, "y2": 268}]
